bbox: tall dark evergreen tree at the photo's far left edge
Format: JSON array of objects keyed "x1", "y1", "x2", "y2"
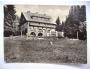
[{"x1": 4, "y1": 5, "x2": 15, "y2": 36}]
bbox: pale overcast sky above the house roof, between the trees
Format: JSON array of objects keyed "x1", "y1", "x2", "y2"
[{"x1": 15, "y1": 5, "x2": 70, "y2": 23}]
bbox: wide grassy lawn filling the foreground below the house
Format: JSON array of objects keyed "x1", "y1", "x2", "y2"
[{"x1": 4, "y1": 37, "x2": 87, "y2": 64}]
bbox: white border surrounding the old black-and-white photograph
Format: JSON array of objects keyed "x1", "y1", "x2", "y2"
[{"x1": 0, "y1": 0, "x2": 90, "y2": 69}]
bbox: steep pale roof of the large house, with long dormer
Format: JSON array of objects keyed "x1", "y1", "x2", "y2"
[{"x1": 21, "y1": 11, "x2": 53, "y2": 24}]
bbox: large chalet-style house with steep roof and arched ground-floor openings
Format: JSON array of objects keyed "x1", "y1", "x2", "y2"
[{"x1": 20, "y1": 11, "x2": 57, "y2": 37}]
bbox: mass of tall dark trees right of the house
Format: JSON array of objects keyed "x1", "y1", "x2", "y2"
[{"x1": 64, "y1": 5, "x2": 86, "y2": 40}]
